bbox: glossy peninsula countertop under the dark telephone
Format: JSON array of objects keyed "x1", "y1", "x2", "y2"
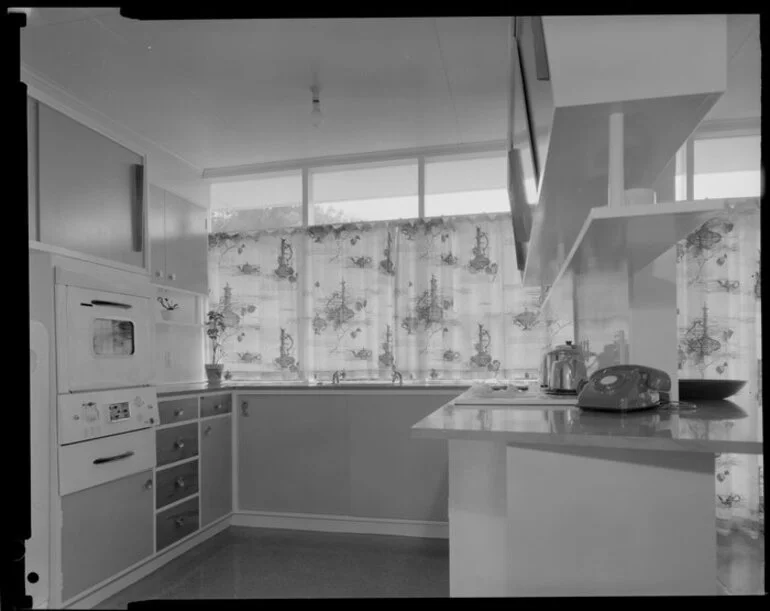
[{"x1": 412, "y1": 397, "x2": 762, "y2": 454}]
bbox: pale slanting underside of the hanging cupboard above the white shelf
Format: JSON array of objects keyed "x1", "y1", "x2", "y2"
[{"x1": 524, "y1": 93, "x2": 719, "y2": 286}]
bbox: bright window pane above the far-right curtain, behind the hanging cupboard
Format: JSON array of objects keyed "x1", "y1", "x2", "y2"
[{"x1": 693, "y1": 135, "x2": 762, "y2": 199}]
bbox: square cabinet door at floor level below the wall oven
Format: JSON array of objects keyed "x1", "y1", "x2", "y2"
[{"x1": 61, "y1": 470, "x2": 155, "y2": 601}]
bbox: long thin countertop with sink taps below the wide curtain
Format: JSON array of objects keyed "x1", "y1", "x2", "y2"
[{"x1": 155, "y1": 382, "x2": 469, "y2": 397}]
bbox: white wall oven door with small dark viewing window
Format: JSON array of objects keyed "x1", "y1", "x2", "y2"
[{"x1": 56, "y1": 285, "x2": 153, "y2": 393}]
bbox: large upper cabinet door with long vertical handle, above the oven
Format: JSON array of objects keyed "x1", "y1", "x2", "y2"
[{"x1": 38, "y1": 104, "x2": 145, "y2": 267}]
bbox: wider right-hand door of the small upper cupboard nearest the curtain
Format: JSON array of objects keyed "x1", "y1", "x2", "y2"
[{"x1": 165, "y1": 191, "x2": 208, "y2": 293}]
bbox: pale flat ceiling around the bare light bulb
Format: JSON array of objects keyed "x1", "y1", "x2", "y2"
[{"x1": 21, "y1": 8, "x2": 509, "y2": 170}]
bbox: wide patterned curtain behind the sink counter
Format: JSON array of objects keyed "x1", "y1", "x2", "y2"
[{"x1": 209, "y1": 214, "x2": 553, "y2": 382}]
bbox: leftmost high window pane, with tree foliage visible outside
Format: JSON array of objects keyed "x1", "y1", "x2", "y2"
[{"x1": 211, "y1": 171, "x2": 302, "y2": 233}]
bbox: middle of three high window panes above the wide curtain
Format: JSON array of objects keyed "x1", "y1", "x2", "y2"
[{"x1": 309, "y1": 159, "x2": 419, "y2": 225}]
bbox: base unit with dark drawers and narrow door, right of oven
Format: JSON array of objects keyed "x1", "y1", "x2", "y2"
[{"x1": 155, "y1": 394, "x2": 232, "y2": 552}]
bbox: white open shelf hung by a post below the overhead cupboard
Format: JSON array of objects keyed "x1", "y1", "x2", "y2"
[{"x1": 543, "y1": 198, "x2": 756, "y2": 305}]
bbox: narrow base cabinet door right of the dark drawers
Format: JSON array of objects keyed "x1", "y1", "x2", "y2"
[{"x1": 200, "y1": 416, "x2": 233, "y2": 526}]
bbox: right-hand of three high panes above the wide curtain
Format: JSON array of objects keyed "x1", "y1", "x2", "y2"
[{"x1": 425, "y1": 153, "x2": 512, "y2": 216}]
